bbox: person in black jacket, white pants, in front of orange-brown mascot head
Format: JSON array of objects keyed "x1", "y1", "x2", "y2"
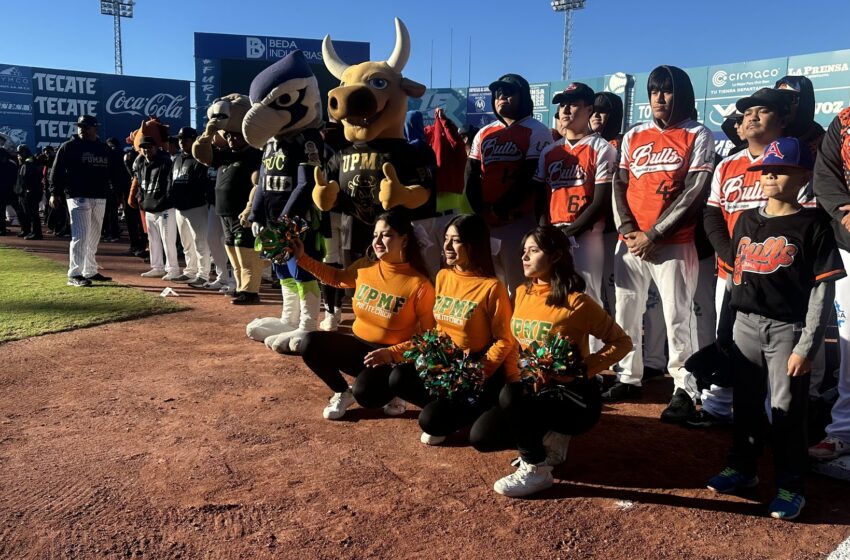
[{"x1": 133, "y1": 136, "x2": 180, "y2": 280}]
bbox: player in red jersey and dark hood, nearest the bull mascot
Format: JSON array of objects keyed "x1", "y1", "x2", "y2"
[{"x1": 466, "y1": 74, "x2": 552, "y2": 293}]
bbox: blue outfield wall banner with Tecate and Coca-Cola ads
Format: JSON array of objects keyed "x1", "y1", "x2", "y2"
[{"x1": 0, "y1": 64, "x2": 189, "y2": 148}]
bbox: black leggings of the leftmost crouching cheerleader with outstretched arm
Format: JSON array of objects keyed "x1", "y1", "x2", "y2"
[{"x1": 301, "y1": 331, "x2": 393, "y2": 408}]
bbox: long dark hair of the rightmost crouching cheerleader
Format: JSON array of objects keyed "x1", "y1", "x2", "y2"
[{"x1": 522, "y1": 226, "x2": 587, "y2": 307}]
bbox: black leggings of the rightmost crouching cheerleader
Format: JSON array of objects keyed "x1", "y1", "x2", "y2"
[{"x1": 470, "y1": 379, "x2": 602, "y2": 464}]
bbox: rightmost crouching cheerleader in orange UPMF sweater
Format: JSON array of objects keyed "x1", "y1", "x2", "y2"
[{"x1": 484, "y1": 226, "x2": 632, "y2": 497}]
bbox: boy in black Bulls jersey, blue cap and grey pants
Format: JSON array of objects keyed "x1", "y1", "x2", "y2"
[{"x1": 708, "y1": 138, "x2": 846, "y2": 519}]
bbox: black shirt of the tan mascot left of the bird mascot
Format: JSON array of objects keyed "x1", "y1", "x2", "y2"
[{"x1": 210, "y1": 146, "x2": 262, "y2": 217}]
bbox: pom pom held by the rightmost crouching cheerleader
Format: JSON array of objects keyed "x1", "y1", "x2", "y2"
[{"x1": 517, "y1": 333, "x2": 587, "y2": 399}]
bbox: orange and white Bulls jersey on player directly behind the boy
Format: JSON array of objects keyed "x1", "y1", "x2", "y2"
[{"x1": 708, "y1": 150, "x2": 817, "y2": 280}]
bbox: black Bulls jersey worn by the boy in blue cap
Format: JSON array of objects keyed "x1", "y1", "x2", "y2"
[{"x1": 732, "y1": 208, "x2": 846, "y2": 323}]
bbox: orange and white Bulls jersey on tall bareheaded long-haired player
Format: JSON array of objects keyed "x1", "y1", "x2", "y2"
[{"x1": 620, "y1": 120, "x2": 714, "y2": 243}]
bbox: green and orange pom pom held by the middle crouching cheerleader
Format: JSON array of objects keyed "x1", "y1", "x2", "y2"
[{"x1": 404, "y1": 329, "x2": 484, "y2": 402}]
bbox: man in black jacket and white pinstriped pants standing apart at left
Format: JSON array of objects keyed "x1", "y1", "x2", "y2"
[{"x1": 50, "y1": 115, "x2": 111, "y2": 287}]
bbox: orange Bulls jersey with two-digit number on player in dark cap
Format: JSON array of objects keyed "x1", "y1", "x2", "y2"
[{"x1": 534, "y1": 134, "x2": 617, "y2": 225}]
